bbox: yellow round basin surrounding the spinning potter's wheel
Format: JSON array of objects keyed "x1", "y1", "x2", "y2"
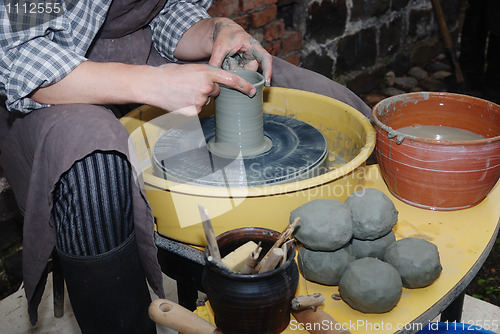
[{"x1": 121, "y1": 88, "x2": 375, "y2": 246}]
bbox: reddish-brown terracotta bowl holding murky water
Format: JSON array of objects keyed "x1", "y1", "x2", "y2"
[{"x1": 373, "y1": 92, "x2": 500, "y2": 210}]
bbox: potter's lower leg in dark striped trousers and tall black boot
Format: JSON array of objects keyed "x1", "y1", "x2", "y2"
[{"x1": 52, "y1": 152, "x2": 156, "y2": 334}]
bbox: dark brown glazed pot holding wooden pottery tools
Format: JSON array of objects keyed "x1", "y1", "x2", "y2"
[{"x1": 203, "y1": 227, "x2": 299, "y2": 334}]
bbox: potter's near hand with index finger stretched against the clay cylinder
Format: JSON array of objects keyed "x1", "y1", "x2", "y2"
[{"x1": 150, "y1": 64, "x2": 256, "y2": 115}]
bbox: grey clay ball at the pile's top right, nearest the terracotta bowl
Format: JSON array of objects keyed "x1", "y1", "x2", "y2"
[{"x1": 345, "y1": 188, "x2": 398, "y2": 240}]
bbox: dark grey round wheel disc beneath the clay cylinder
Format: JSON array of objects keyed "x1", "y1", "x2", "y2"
[{"x1": 152, "y1": 114, "x2": 328, "y2": 187}]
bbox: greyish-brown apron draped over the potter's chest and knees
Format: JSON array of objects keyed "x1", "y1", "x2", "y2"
[{"x1": 0, "y1": 0, "x2": 166, "y2": 324}]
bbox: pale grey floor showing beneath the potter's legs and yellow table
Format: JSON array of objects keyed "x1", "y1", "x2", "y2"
[{"x1": 0, "y1": 275, "x2": 500, "y2": 334}]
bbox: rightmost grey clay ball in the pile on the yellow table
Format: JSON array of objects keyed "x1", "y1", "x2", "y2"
[{"x1": 384, "y1": 238, "x2": 443, "y2": 289}]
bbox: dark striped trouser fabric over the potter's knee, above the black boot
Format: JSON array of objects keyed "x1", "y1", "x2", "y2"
[{"x1": 52, "y1": 152, "x2": 133, "y2": 256}]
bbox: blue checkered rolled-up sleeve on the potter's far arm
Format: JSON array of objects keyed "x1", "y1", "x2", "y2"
[{"x1": 150, "y1": 0, "x2": 212, "y2": 62}]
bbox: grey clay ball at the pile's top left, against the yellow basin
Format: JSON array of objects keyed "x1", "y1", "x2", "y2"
[{"x1": 290, "y1": 199, "x2": 352, "y2": 251}]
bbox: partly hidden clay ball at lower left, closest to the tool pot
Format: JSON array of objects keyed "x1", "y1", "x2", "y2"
[{"x1": 297, "y1": 245, "x2": 355, "y2": 285}]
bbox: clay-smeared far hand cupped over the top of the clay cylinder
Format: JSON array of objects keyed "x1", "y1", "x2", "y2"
[{"x1": 208, "y1": 18, "x2": 272, "y2": 86}]
